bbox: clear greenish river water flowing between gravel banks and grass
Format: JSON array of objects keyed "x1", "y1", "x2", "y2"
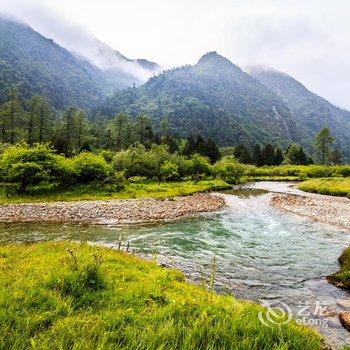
[{"x1": 0, "y1": 183, "x2": 350, "y2": 349}]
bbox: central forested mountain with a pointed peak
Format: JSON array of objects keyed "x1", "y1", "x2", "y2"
[{"x1": 98, "y1": 52, "x2": 298, "y2": 145}]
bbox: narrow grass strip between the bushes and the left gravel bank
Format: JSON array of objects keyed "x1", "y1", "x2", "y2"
[{"x1": 0, "y1": 179, "x2": 232, "y2": 204}]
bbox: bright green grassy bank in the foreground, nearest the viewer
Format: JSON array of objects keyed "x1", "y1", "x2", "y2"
[{"x1": 0, "y1": 242, "x2": 323, "y2": 350}]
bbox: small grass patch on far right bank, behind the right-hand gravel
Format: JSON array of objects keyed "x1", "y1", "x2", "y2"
[{"x1": 299, "y1": 177, "x2": 350, "y2": 198}]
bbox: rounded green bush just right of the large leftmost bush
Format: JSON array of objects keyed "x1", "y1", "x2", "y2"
[{"x1": 72, "y1": 152, "x2": 111, "y2": 184}]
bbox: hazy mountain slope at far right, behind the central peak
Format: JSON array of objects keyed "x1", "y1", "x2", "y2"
[{"x1": 248, "y1": 67, "x2": 350, "y2": 160}]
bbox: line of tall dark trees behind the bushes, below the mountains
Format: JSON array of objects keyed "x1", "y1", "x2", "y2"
[{"x1": 0, "y1": 88, "x2": 341, "y2": 166}]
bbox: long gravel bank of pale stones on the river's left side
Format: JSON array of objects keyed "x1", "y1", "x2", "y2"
[{"x1": 0, "y1": 193, "x2": 225, "y2": 225}]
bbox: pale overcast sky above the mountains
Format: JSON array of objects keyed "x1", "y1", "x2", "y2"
[{"x1": 0, "y1": 0, "x2": 350, "y2": 109}]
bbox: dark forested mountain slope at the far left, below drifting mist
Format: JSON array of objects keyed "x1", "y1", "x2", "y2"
[{"x1": 0, "y1": 17, "x2": 113, "y2": 108}]
